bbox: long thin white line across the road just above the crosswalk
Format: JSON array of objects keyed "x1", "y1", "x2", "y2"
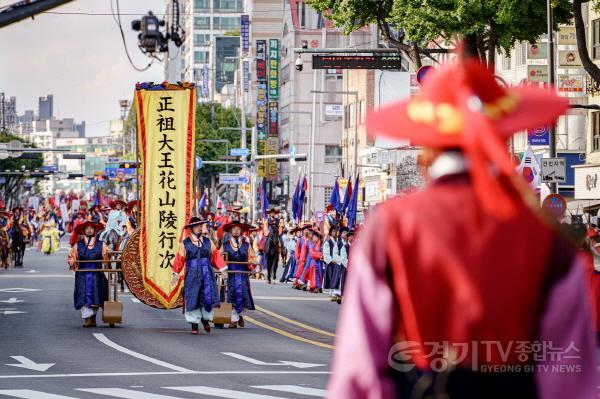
[{"x1": 0, "y1": 370, "x2": 331, "y2": 380}]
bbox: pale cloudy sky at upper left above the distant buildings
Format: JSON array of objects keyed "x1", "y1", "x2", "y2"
[{"x1": 0, "y1": 0, "x2": 164, "y2": 136}]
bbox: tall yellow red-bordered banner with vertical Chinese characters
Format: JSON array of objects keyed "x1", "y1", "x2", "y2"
[{"x1": 135, "y1": 83, "x2": 196, "y2": 309}]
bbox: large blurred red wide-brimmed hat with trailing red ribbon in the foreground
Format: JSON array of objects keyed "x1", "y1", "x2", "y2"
[{"x1": 367, "y1": 58, "x2": 569, "y2": 217}]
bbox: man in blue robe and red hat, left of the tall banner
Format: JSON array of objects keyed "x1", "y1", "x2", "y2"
[{"x1": 67, "y1": 221, "x2": 108, "y2": 327}]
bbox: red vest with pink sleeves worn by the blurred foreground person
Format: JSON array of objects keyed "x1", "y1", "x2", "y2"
[{"x1": 328, "y1": 161, "x2": 596, "y2": 399}]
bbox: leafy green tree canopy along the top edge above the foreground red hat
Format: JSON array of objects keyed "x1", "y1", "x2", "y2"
[{"x1": 307, "y1": 0, "x2": 581, "y2": 68}]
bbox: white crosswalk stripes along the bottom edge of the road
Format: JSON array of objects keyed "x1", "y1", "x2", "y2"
[{"x1": 0, "y1": 385, "x2": 326, "y2": 399}]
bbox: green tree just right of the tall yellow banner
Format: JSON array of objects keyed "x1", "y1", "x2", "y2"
[{"x1": 196, "y1": 103, "x2": 251, "y2": 185}]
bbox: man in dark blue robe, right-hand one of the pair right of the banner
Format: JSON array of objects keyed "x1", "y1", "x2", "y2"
[{"x1": 221, "y1": 221, "x2": 255, "y2": 327}]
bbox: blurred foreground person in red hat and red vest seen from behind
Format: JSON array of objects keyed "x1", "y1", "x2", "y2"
[{"x1": 327, "y1": 47, "x2": 597, "y2": 399}]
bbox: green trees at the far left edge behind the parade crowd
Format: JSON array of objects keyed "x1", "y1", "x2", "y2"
[{"x1": 0, "y1": 131, "x2": 43, "y2": 207}]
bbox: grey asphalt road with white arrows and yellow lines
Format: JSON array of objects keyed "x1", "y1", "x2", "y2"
[{"x1": 0, "y1": 239, "x2": 339, "y2": 399}]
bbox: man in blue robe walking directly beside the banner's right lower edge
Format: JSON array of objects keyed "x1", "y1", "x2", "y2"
[{"x1": 173, "y1": 216, "x2": 219, "y2": 334}]
